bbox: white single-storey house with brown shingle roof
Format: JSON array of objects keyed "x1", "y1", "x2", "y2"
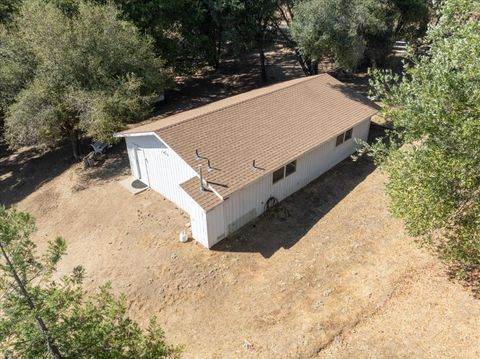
[{"x1": 116, "y1": 74, "x2": 377, "y2": 248}]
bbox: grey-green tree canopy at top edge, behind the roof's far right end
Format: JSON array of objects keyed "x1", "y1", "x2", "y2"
[{"x1": 292, "y1": 0, "x2": 429, "y2": 69}]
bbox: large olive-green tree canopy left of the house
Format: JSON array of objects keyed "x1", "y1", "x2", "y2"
[{"x1": 0, "y1": 0, "x2": 168, "y2": 159}]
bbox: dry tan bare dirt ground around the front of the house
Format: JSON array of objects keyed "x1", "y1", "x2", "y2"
[{"x1": 0, "y1": 48, "x2": 480, "y2": 358}]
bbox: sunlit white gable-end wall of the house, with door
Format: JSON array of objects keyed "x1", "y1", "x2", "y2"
[{"x1": 125, "y1": 135, "x2": 209, "y2": 247}]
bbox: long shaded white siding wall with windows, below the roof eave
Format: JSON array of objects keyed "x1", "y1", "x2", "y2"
[{"x1": 207, "y1": 120, "x2": 370, "y2": 247}]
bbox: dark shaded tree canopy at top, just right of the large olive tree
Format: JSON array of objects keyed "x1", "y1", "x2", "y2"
[{"x1": 96, "y1": 0, "x2": 227, "y2": 74}]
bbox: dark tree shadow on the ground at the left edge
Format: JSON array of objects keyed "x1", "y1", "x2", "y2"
[{"x1": 0, "y1": 142, "x2": 73, "y2": 206}]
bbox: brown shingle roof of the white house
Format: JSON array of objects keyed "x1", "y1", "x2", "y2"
[{"x1": 118, "y1": 74, "x2": 378, "y2": 210}]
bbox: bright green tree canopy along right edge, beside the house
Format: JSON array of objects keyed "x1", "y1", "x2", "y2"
[{"x1": 368, "y1": 0, "x2": 480, "y2": 286}]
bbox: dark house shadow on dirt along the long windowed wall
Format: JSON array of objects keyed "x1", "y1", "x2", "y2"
[{"x1": 212, "y1": 129, "x2": 382, "y2": 258}]
